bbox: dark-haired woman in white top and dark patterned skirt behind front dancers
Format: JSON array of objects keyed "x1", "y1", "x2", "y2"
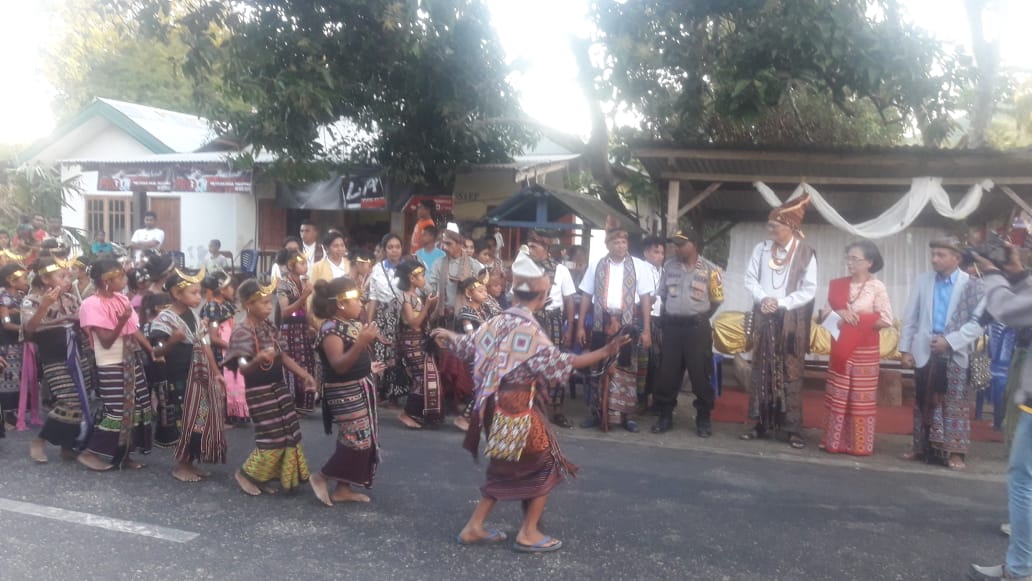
[{"x1": 365, "y1": 233, "x2": 409, "y2": 408}]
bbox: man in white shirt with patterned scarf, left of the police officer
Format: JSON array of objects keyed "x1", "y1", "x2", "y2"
[{"x1": 577, "y1": 218, "x2": 655, "y2": 431}]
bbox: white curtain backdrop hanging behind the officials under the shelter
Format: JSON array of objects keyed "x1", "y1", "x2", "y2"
[{"x1": 721, "y1": 222, "x2": 944, "y2": 319}]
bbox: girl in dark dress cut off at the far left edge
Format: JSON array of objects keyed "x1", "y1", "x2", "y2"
[{"x1": 0, "y1": 262, "x2": 27, "y2": 429}]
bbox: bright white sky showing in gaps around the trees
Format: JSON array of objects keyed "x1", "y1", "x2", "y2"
[{"x1": 0, "y1": 0, "x2": 1032, "y2": 143}]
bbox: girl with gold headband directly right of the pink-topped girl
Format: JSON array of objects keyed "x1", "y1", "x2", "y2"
[{"x1": 151, "y1": 268, "x2": 226, "y2": 482}]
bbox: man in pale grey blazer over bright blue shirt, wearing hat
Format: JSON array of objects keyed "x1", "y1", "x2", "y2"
[{"x1": 900, "y1": 236, "x2": 985, "y2": 470}]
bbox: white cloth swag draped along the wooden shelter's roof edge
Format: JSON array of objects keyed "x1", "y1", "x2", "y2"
[{"x1": 753, "y1": 177, "x2": 993, "y2": 239}]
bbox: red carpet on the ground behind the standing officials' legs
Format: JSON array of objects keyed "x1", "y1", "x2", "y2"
[{"x1": 713, "y1": 387, "x2": 1003, "y2": 442}]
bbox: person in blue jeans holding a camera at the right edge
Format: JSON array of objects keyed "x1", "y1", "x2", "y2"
[{"x1": 968, "y1": 249, "x2": 1032, "y2": 581}]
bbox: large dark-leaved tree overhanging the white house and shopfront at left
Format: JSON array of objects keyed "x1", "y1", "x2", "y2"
[{"x1": 114, "y1": 0, "x2": 530, "y2": 188}]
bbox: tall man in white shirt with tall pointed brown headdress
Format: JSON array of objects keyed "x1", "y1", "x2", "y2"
[{"x1": 742, "y1": 194, "x2": 817, "y2": 448}]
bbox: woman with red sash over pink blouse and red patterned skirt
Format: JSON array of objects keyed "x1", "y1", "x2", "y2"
[{"x1": 820, "y1": 240, "x2": 893, "y2": 456}]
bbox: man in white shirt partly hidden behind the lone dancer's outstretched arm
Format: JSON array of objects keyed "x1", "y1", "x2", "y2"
[{"x1": 526, "y1": 230, "x2": 577, "y2": 427}]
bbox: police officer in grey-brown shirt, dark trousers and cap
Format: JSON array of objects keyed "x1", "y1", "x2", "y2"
[{"x1": 652, "y1": 230, "x2": 723, "y2": 438}]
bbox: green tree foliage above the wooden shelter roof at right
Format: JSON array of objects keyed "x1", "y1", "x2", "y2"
[{"x1": 594, "y1": 0, "x2": 971, "y2": 144}]
